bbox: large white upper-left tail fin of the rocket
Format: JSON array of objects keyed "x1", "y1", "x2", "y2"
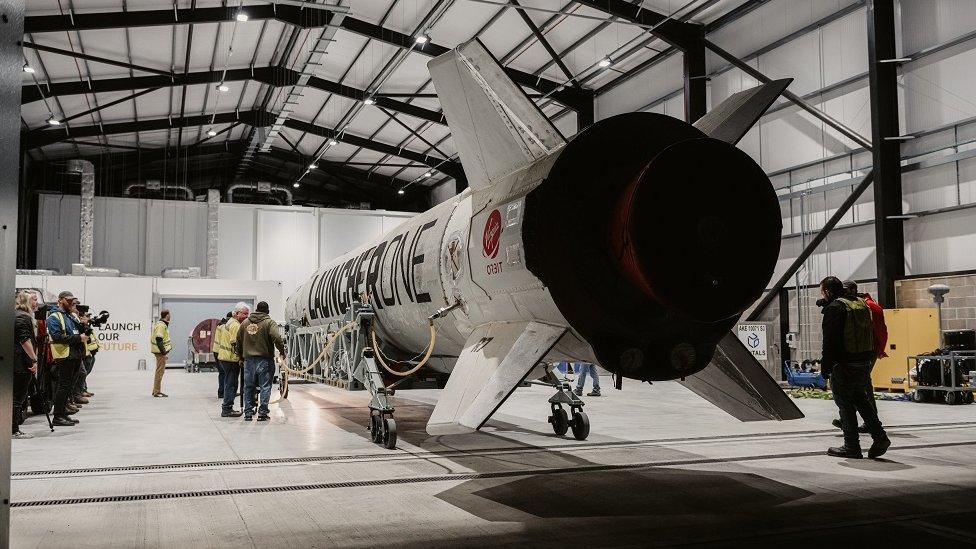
[{"x1": 427, "y1": 40, "x2": 566, "y2": 189}]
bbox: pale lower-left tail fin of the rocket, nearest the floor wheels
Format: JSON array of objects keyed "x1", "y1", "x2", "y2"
[{"x1": 427, "y1": 322, "x2": 566, "y2": 435}]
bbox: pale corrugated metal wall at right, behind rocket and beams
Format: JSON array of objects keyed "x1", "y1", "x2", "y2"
[{"x1": 596, "y1": 0, "x2": 976, "y2": 284}]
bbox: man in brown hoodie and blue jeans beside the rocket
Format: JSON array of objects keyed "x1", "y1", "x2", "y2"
[{"x1": 234, "y1": 301, "x2": 285, "y2": 421}]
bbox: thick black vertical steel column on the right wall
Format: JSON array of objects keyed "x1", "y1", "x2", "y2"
[{"x1": 867, "y1": 0, "x2": 905, "y2": 308}]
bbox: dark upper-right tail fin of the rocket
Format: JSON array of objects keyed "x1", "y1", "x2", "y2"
[{"x1": 692, "y1": 78, "x2": 793, "y2": 145}]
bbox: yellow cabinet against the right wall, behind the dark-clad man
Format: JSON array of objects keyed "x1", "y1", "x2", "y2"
[{"x1": 871, "y1": 308, "x2": 939, "y2": 392}]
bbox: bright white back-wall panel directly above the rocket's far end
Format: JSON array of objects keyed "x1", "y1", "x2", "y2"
[{"x1": 255, "y1": 209, "x2": 318, "y2": 294}]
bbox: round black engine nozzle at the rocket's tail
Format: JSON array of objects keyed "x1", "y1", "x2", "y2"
[{"x1": 610, "y1": 138, "x2": 782, "y2": 322}]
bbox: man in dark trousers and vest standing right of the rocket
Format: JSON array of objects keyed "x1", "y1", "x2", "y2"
[{"x1": 820, "y1": 276, "x2": 891, "y2": 459}]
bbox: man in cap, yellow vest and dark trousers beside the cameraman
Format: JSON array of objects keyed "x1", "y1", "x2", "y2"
[{"x1": 44, "y1": 291, "x2": 88, "y2": 427}]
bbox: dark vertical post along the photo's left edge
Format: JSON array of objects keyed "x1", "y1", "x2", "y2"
[{"x1": 0, "y1": 0, "x2": 24, "y2": 547}]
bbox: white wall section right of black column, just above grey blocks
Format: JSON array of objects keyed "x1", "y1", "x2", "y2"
[{"x1": 905, "y1": 208, "x2": 976, "y2": 275}]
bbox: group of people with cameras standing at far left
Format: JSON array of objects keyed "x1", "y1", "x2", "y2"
[{"x1": 12, "y1": 291, "x2": 99, "y2": 439}]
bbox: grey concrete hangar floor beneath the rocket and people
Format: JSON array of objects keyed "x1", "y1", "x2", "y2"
[{"x1": 11, "y1": 369, "x2": 976, "y2": 548}]
